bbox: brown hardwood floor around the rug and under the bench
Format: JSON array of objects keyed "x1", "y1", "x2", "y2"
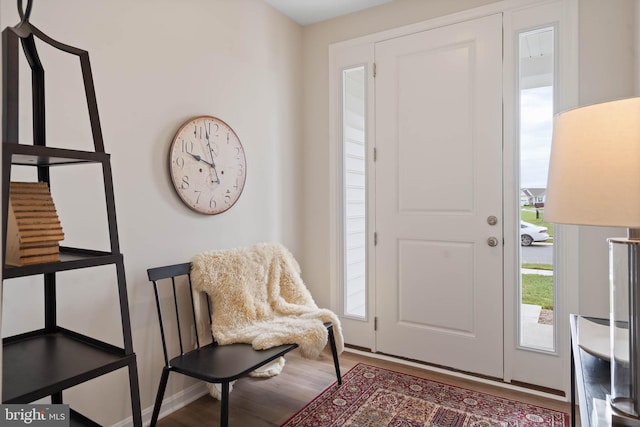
[{"x1": 158, "y1": 351, "x2": 571, "y2": 427}]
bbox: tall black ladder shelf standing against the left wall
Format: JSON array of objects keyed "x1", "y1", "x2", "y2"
[{"x1": 2, "y1": 0, "x2": 142, "y2": 426}]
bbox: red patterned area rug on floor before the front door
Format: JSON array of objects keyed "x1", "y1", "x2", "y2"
[{"x1": 283, "y1": 363, "x2": 569, "y2": 427}]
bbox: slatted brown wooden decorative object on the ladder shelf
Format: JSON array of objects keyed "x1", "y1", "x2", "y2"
[{"x1": 6, "y1": 182, "x2": 64, "y2": 266}]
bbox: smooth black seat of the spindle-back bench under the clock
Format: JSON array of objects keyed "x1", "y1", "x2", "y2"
[{"x1": 169, "y1": 344, "x2": 298, "y2": 383}]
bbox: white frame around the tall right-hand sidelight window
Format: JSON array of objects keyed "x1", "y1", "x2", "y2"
[{"x1": 503, "y1": 0, "x2": 579, "y2": 396}]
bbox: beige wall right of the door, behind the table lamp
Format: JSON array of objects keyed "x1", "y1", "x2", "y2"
[{"x1": 577, "y1": 0, "x2": 638, "y2": 317}]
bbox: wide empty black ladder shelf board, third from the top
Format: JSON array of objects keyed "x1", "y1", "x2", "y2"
[{"x1": 2, "y1": 329, "x2": 135, "y2": 403}]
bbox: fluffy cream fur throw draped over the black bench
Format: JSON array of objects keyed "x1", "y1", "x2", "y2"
[{"x1": 191, "y1": 244, "x2": 344, "y2": 358}]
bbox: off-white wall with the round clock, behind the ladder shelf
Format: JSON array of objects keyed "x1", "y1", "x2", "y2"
[{"x1": 0, "y1": 0, "x2": 302, "y2": 425}]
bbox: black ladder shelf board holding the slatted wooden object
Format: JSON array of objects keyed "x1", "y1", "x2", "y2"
[{"x1": 2, "y1": 246, "x2": 122, "y2": 279}]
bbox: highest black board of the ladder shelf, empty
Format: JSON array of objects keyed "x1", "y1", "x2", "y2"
[{"x1": 3, "y1": 142, "x2": 109, "y2": 166}]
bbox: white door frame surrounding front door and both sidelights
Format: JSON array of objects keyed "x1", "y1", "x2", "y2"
[{"x1": 329, "y1": 0, "x2": 579, "y2": 396}]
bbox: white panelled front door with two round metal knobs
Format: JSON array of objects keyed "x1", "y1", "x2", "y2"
[{"x1": 375, "y1": 14, "x2": 503, "y2": 378}]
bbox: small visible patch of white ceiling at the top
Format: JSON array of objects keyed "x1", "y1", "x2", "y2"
[{"x1": 264, "y1": 0, "x2": 393, "y2": 25}]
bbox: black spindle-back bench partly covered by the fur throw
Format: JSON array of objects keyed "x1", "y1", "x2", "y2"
[{"x1": 147, "y1": 262, "x2": 342, "y2": 427}]
